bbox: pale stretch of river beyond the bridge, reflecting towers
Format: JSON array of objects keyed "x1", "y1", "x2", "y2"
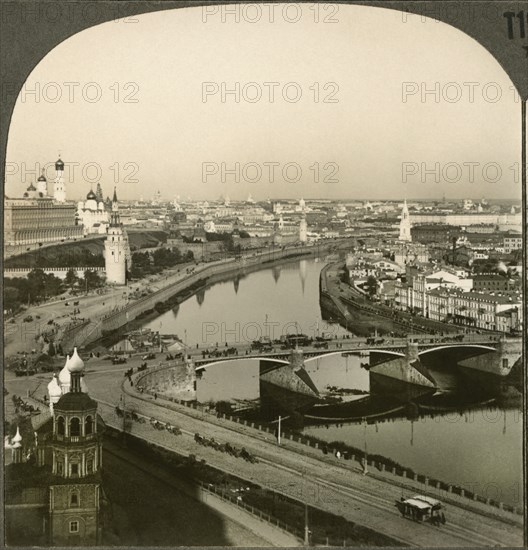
[{"x1": 143, "y1": 260, "x2": 346, "y2": 345}]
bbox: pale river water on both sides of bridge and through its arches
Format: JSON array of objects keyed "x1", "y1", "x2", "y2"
[{"x1": 141, "y1": 259, "x2": 523, "y2": 506}]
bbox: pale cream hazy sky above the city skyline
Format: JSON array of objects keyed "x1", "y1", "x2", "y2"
[{"x1": 6, "y1": 4, "x2": 521, "y2": 200}]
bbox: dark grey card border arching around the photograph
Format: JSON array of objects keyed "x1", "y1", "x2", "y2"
[{"x1": 0, "y1": 0, "x2": 528, "y2": 545}]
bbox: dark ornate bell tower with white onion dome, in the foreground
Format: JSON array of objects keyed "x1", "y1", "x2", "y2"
[{"x1": 50, "y1": 349, "x2": 102, "y2": 547}]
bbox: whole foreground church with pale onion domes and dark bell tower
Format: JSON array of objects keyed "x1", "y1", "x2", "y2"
[{"x1": 5, "y1": 349, "x2": 108, "y2": 547}]
